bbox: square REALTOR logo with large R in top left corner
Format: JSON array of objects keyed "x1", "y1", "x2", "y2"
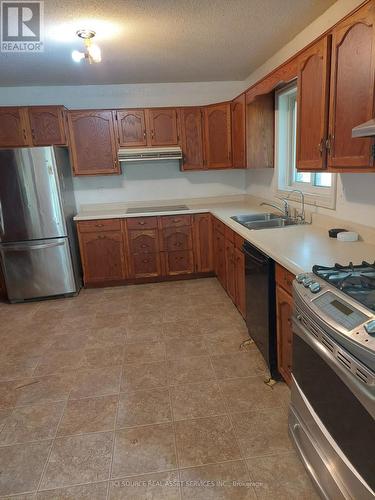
[{"x1": 0, "y1": 0, "x2": 44, "y2": 52}]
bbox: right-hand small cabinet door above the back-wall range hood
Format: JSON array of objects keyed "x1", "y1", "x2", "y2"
[{"x1": 147, "y1": 108, "x2": 178, "y2": 146}]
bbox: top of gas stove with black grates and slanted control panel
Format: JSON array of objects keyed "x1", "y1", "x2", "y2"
[{"x1": 294, "y1": 262, "x2": 375, "y2": 371}]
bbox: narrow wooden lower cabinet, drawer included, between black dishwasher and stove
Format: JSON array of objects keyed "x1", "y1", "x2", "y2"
[{"x1": 276, "y1": 265, "x2": 293, "y2": 385}]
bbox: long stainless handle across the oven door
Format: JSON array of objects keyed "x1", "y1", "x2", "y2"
[{"x1": 292, "y1": 316, "x2": 375, "y2": 418}]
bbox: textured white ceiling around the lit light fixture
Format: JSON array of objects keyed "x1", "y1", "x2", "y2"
[{"x1": 0, "y1": 0, "x2": 335, "y2": 85}]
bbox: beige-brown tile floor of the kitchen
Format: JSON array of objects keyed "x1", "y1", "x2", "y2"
[{"x1": 0, "y1": 279, "x2": 317, "y2": 500}]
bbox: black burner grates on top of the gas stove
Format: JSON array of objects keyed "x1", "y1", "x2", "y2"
[{"x1": 313, "y1": 262, "x2": 375, "y2": 311}]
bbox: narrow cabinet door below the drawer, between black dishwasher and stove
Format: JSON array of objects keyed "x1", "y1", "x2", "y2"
[{"x1": 276, "y1": 286, "x2": 293, "y2": 385}]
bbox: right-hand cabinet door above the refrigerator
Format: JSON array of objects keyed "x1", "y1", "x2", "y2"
[{"x1": 28, "y1": 106, "x2": 66, "y2": 146}]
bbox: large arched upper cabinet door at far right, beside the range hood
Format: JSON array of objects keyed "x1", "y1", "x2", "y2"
[{"x1": 328, "y1": 2, "x2": 375, "y2": 170}]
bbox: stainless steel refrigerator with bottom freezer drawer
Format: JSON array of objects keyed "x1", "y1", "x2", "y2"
[{"x1": 0, "y1": 146, "x2": 81, "y2": 302}]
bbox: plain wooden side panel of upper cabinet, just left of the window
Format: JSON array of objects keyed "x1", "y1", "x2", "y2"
[{"x1": 246, "y1": 92, "x2": 275, "y2": 168}]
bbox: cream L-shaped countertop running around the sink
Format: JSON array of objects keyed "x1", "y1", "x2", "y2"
[{"x1": 74, "y1": 201, "x2": 375, "y2": 274}]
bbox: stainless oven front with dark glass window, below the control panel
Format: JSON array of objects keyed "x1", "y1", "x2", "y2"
[{"x1": 289, "y1": 316, "x2": 375, "y2": 500}]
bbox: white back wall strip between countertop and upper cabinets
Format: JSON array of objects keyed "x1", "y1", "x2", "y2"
[{"x1": 74, "y1": 160, "x2": 246, "y2": 205}]
